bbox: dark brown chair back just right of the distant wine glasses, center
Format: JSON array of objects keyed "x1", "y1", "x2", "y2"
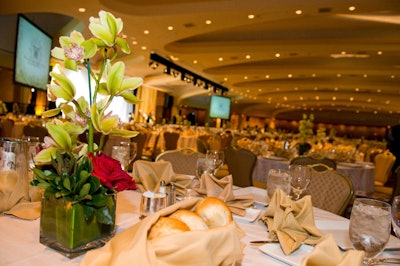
[{"x1": 225, "y1": 146, "x2": 257, "y2": 187}]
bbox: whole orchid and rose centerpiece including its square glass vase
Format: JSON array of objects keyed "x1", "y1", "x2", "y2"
[{"x1": 31, "y1": 11, "x2": 143, "y2": 257}]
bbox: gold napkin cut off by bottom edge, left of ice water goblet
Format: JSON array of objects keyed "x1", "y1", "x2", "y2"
[{"x1": 301, "y1": 234, "x2": 365, "y2": 266}]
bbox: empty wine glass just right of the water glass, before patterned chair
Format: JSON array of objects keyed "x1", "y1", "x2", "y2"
[{"x1": 289, "y1": 164, "x2": 311, "y2": 200}]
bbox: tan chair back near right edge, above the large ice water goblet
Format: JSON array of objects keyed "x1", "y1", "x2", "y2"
[{"x1": 375, "y1": 150, "x2": 396, "y2": 186}]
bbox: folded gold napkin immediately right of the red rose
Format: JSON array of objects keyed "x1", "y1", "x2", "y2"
[{"x1": 132, "y1": 160, "x2": 192, "y2": 195}]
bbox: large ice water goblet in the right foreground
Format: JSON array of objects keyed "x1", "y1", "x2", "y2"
[{"x1": 349, "y1": 198, "x2": 391, "y2": 265}]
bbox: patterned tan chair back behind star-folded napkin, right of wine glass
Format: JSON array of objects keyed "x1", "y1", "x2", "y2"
[{"x1": 306, "y1": 164, "x2": 354, "y2": 215}]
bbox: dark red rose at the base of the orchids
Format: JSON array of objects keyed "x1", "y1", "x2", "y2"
[{"x1": 89, "y1": 153, "x2": 136, "y2": 191}]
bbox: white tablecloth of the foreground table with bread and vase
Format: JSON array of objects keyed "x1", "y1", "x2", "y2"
[{"x1": 0, "y1": 191, "x2": 400, "y2": 266}]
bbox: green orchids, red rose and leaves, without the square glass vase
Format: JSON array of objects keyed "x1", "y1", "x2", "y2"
[{"x1": 31, "y1": 11, "x2": 143, "y2": 222}]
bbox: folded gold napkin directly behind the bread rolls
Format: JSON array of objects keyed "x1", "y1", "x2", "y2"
[{"x1": 193, "y1": 174, "x2": 254, "y2": 216}]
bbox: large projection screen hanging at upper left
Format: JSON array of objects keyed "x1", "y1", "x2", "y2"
[{"x1": 14, "y1": 14, "x2": 53, "y2": 90}]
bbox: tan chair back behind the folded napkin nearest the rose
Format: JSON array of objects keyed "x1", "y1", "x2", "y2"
[{"x1": 155, "y1": 148, "x2": 204, "y2": 176}]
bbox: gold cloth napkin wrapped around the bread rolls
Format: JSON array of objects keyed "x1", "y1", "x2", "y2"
[{"x1": 80, "y1": 198, "x2": 244, "y2": 266}]
